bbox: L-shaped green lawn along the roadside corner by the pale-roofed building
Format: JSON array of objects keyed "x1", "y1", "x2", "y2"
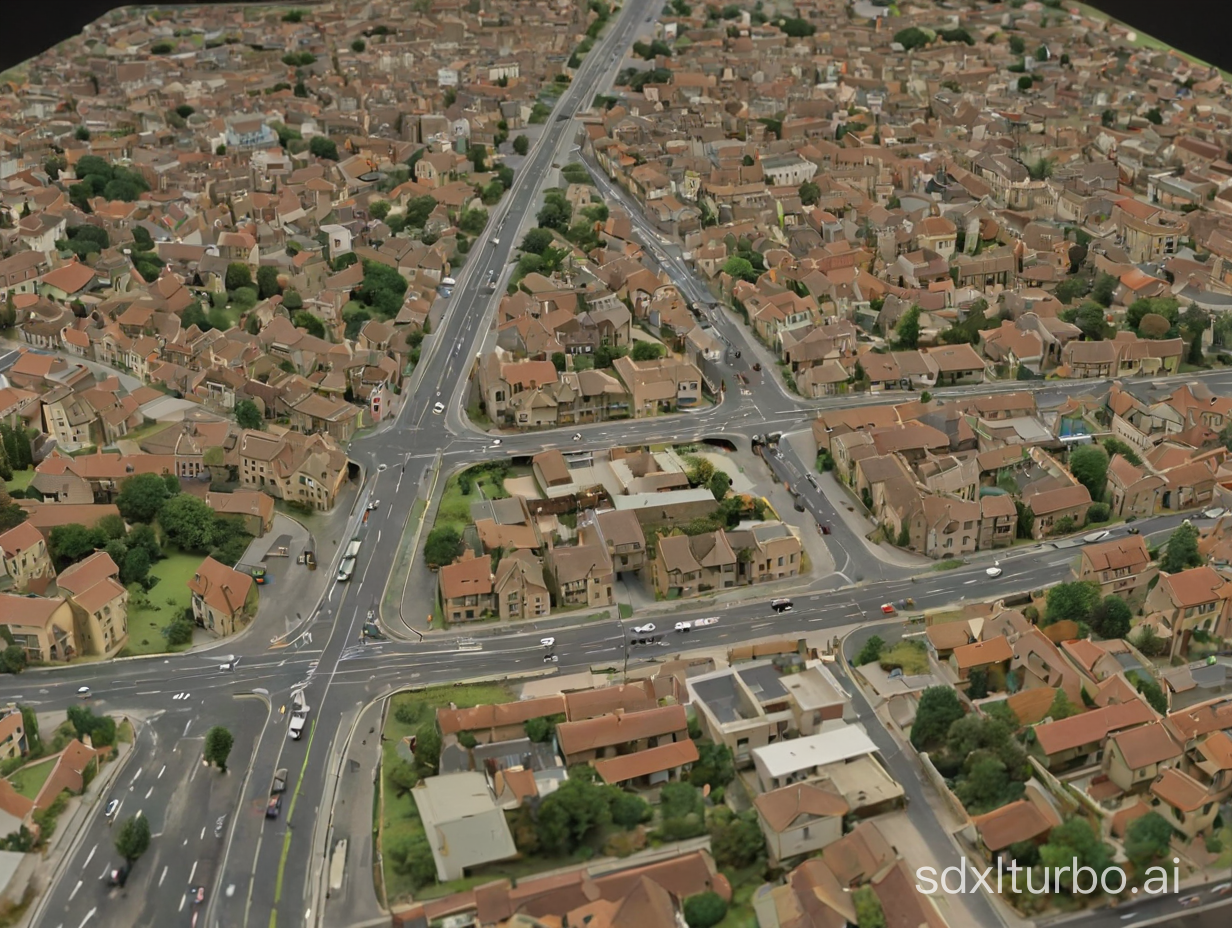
[{"x1": 378, "y1": 683, "x2": 513, "y2": 903}]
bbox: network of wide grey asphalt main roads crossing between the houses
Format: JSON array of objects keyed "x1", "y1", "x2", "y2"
[{"x1": 7, "y1": 0, "x2": 1232, "y2": 928}]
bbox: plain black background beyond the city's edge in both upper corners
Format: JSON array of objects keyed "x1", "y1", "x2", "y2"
[{"x1": 0, "y1": 0, "x2": 1232, "y2": 85}]
